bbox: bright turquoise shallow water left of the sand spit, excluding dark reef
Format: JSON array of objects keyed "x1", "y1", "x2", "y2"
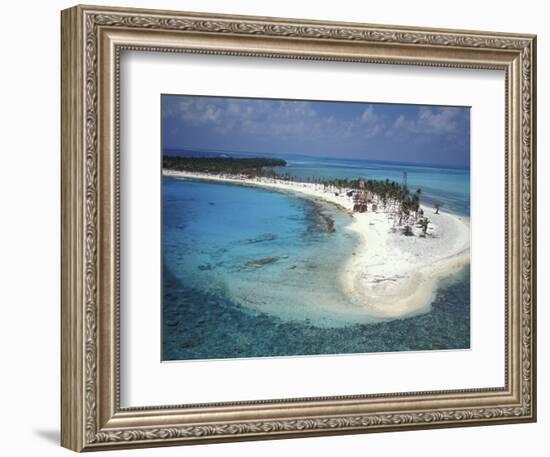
[{"x1": 163, "y1": 178, "x2": 364, "y2": 326}]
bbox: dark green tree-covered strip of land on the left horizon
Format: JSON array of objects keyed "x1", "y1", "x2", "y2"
[{"x1": 162, "y1": 156, "x2": 286, "y2": 177}]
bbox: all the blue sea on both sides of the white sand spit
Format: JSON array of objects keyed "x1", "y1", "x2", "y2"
[{"x1": 162, "y1": 156, "x2": 470, "y2": 360}]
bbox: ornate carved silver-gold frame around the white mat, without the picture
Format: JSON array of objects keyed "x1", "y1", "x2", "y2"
[{"x1": 61, "y1": 6, "x2": 536, "y2": 451}]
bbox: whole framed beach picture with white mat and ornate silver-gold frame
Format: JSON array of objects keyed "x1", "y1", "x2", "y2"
[{"x1": 61, "y1": 6, "x2": 536, "y2": 451}]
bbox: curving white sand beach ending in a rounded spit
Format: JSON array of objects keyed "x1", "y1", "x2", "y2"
[{"x1": 163, "y1": 170, "x2": 470, "y2": 319}]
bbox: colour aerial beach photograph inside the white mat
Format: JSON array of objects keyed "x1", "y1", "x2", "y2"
[{"x1": 161, "y1": 94, "x2": 470, "y2": 361}]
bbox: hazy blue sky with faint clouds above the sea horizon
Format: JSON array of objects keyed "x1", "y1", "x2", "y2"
[{"x1": 162, "y1": 95, "x2": 470, "y2": 167}]
